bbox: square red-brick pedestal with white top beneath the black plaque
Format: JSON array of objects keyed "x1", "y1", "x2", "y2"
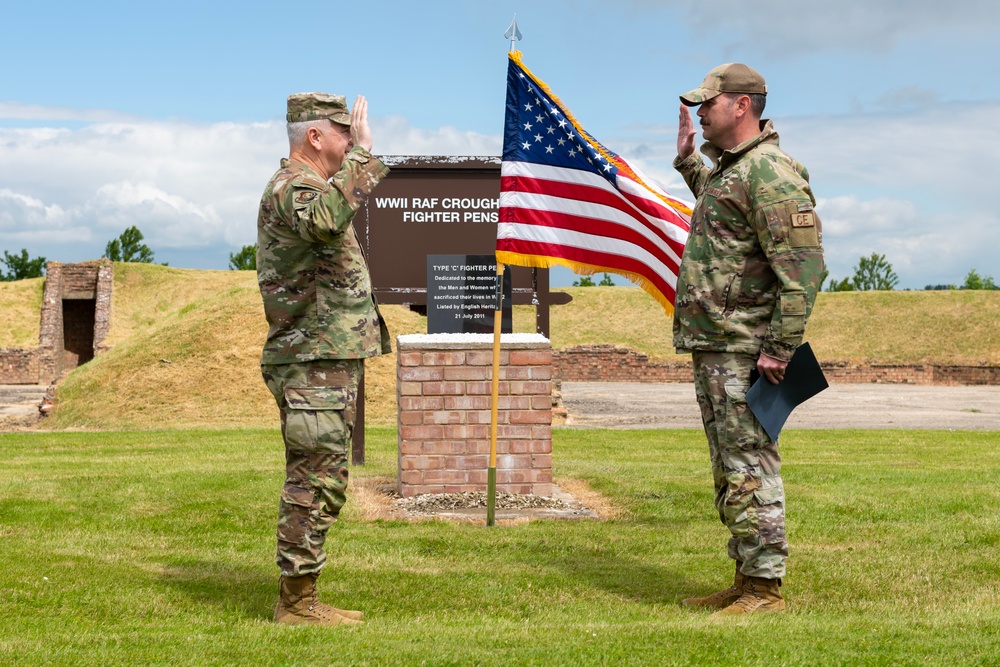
[{"x1": 396, "y1": 334, "x2": 552, "y2": 497}]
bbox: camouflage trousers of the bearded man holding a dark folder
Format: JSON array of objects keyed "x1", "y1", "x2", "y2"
[{"x1": 693, "y1": 352, "x2": 788, "y2": 579}]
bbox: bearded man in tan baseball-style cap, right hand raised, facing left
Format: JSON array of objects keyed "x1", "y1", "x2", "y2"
[{"x1": 674, "y1": 63, "x2": 823, "y2": 615}]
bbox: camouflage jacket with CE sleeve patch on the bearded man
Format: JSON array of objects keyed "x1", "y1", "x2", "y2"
[{"x1": 674, "y1": 121, "x2": 823, "y2": 361}]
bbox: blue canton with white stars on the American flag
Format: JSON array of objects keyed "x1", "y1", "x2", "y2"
[{"x1": 503, "y1": 54, "x2": 618, "y2": 184}]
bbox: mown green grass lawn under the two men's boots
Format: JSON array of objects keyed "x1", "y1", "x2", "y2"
[{"x1": 0, "y1": 429, "x2": 1000, "y2": 666}]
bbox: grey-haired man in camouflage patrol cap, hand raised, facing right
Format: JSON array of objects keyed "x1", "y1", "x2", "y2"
[{"x1": 257, "y1": 93, "x2": 391, "y2": 625}]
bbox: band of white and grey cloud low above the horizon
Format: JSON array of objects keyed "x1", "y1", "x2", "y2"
[{"x1": 0, "y1": 103, "x2": 1000, "y2": 287}]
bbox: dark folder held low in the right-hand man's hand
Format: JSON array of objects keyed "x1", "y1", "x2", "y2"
[{"x1": 747, "y1": 343, "x2": 830, "y2": 442}]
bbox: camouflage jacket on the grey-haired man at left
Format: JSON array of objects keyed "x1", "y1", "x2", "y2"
[{"x1": 257, "y1": 146, "x2": 391, "y2": 364}]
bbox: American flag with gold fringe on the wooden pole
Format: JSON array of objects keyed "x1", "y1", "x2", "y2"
[{"x1": 496, "y1": 51, "x2": 691, "y2": 314}]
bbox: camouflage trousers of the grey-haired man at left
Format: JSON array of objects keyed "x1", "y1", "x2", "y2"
[{"x1": 261, "y1": 359, "x2": 364, "y2": 577}]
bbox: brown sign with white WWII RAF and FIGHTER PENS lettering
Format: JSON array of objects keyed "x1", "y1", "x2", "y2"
[{"x1": 355, "y1": 155, "x2": 571, "y2": 336}]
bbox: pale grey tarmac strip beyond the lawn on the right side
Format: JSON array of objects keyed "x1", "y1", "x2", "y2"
[{"x1": 562, "y1": 382, "x2": 1000, "y2": 431}]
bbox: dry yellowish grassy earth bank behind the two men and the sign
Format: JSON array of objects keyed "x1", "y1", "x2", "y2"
[{"x1": 0, "y1": 263, "x2": 1000, "y2": 429}]
